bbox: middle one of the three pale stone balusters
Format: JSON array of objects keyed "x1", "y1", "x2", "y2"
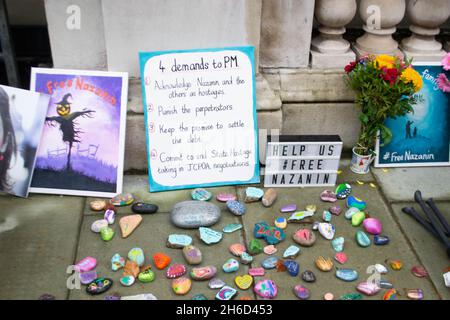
[{"x1": 354, "y1": 0, "x2": 406, "y2": 56}]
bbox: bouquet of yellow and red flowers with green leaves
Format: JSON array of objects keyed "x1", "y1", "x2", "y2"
[{"x1": 345, "y1": 55, "x2": 423, "y2": 155}]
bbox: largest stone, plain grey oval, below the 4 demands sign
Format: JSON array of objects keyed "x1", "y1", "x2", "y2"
[{"x1": 170, "y1": 201, "x2": 220, "y2": 229}]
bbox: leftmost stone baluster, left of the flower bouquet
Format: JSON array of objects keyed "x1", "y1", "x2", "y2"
[{"x1": 311, "y1": 0, "x2": 357, "y2": 69}]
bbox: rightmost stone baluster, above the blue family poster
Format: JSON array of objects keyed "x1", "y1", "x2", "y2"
[{"x1": 402, "y1": 0, "x2": 450, "y2": 61}]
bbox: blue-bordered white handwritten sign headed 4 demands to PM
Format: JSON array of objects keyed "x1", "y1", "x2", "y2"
[{"x1": 140, "y1": 47, "x2": 259, "y2": 192}]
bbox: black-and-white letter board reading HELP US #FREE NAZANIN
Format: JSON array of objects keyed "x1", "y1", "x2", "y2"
[{"x1": 264, "y1": 135, "x2": 342, "y2": 187}]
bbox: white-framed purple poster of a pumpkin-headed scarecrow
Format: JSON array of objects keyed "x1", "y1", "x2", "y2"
[{"x1": 30, "y1": 68, "x2": 128, "y2": 197}]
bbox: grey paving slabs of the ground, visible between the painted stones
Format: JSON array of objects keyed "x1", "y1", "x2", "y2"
[{"x1": 0, "y1": 160, "x2": 450, "y2": 299}]
